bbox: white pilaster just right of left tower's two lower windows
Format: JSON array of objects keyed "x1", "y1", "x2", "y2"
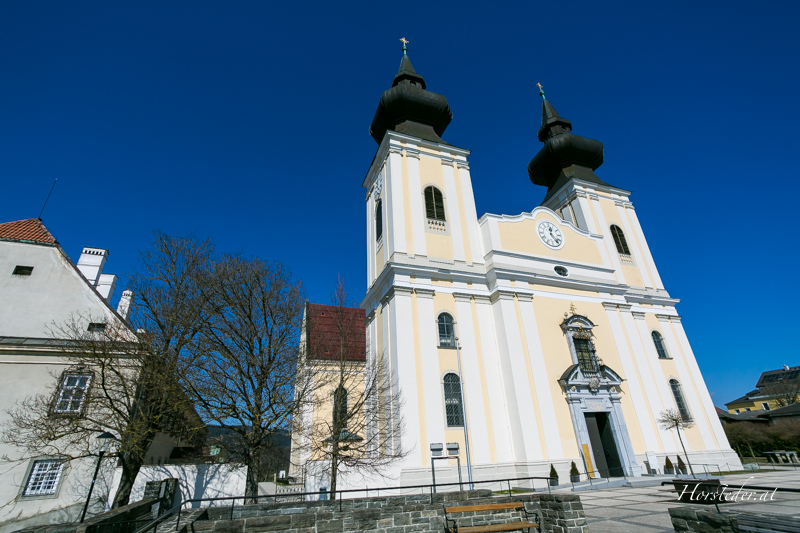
[{"x1": 453, "y1": 294, "x2": 491, "y2": 463}]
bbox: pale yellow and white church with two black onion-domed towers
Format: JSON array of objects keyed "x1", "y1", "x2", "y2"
[{"x1": 354, "y1": 46, "x2": 740, "y2": 490}]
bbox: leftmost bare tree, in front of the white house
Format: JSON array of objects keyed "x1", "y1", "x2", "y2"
[{"x1": 0, "y1": 233, "x2": 212, "y2": 507}]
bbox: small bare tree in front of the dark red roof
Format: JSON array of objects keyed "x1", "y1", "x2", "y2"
[{"x1": 298, "y1": 278, "x2": 408, "y2": 499}]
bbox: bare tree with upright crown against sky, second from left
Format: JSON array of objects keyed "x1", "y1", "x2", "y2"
[{"x1": 184, "y1": 256, "x2": 311, "y2": 498}]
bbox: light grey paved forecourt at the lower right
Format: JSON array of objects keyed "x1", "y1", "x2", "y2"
[{"x1": 578, "y1": 470, "x2": 800, "y2": 533}]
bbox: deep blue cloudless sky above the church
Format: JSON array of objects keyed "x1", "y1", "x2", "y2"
[{"x1": 0, "y1": 1, "x2": 800, "y2": 405}]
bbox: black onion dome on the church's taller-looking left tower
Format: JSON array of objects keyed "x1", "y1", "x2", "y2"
[{"x1": 369, "y1": 54, "x2": 453, "y2": 144}]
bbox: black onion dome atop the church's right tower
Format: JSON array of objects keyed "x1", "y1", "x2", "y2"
[{"x1": 528, "y1": 85, "x2": 610, "y2": 204}]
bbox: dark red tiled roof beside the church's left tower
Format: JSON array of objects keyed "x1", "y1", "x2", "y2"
[{"x1": 306, "y1": 303, "x2": 367, "y2": 361}]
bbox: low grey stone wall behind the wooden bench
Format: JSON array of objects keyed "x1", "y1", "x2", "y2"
[{"x1": 190, "y1": 490, "x2": 588, "y2": 533}]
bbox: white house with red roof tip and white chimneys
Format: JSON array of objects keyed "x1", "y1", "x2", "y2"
[{"x1": 0, "y1": 218, "x2": 131, "y2": 532}]
